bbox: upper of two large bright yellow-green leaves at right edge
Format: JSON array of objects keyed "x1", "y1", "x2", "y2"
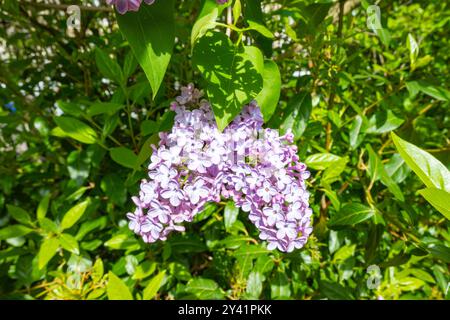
[{"x1": 391, "y1": 132, "x2": 450, "y2": 192}]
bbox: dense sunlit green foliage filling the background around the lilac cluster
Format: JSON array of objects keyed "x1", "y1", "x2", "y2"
[{"x1": 0, "y1": 0, "x2": 450, "y2": 299}]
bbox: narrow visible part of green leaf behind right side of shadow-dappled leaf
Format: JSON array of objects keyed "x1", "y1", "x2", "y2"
[{"x1": 255, "y1": 60, "x2": 281, "y2": 122}]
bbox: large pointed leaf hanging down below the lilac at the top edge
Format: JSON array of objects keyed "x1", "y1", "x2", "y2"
[{"x1": 116, "y1": 0, "x2": 175, "y2": 99}]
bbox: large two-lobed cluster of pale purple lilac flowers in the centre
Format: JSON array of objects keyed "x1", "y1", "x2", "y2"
[{"x1": 127, "y1": 85, "x2": 312, "y2": 252}]
